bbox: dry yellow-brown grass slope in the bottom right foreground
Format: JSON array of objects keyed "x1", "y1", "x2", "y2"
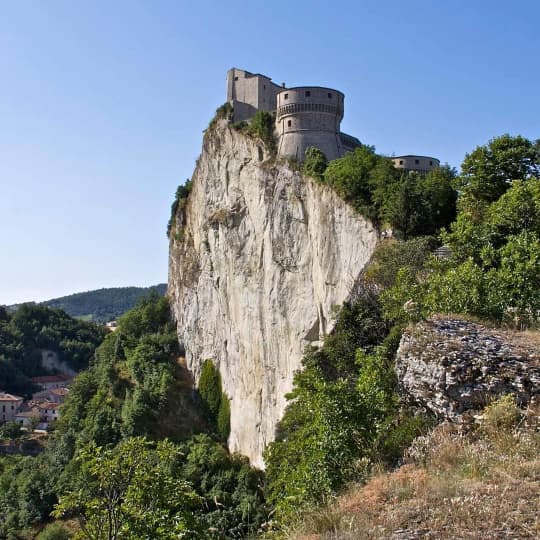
[{"x1": 287, "y1": 400, "x2": 540, "y2": 540}]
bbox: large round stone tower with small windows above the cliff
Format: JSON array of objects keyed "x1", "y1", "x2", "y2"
[{"x1": 276, "y1": 86, "x2": 344, "y2": 162}]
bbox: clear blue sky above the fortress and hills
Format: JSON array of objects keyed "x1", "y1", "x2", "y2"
[{"x1": 0, "y1": 0, "x2": 540, "y2": 304}]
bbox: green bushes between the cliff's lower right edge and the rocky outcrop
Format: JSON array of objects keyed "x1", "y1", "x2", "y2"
[{"x1": 265, "y1": 292, "x2": 396, "y2": 517}]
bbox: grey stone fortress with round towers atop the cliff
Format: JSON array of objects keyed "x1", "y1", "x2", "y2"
[{"x1": 227, "y1": 68, "x2": 440, "y2": 174}]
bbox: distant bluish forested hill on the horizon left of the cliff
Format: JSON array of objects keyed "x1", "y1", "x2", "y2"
[{"x1": 10, "y1": 283, "x2": 167, "y2": 323}]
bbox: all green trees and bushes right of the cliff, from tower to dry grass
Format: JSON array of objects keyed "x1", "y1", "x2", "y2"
[{"x1": 265, "y1": 135, "x2": 540, "y2": 521}]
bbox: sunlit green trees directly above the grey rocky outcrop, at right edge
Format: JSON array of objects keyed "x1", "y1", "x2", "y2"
[{"x1": 382, "y1": 136, "x2": 540, "y2": 328}]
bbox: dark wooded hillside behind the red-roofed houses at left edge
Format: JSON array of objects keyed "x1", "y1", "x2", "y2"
[{"x1": 0, "y1": 304, "x2": 106, "y2": 397}]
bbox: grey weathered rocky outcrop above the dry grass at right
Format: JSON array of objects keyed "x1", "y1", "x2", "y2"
[{"x1": 396, "y1": 318, "x2": 540, "y2": 421}]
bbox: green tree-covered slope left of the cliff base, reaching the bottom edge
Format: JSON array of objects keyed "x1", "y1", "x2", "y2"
[{"x1": 0, "y1": 295, "x2": 269, "y2": 539}]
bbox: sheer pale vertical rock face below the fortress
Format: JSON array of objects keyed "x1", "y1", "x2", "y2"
[{"x1": 169, "y1": 121, "x2": 378, "y2": 467}]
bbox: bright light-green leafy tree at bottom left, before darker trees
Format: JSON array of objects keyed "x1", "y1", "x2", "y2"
[{"x1": 53, "y1": 438, "x2": 200, "y2": 540}]
